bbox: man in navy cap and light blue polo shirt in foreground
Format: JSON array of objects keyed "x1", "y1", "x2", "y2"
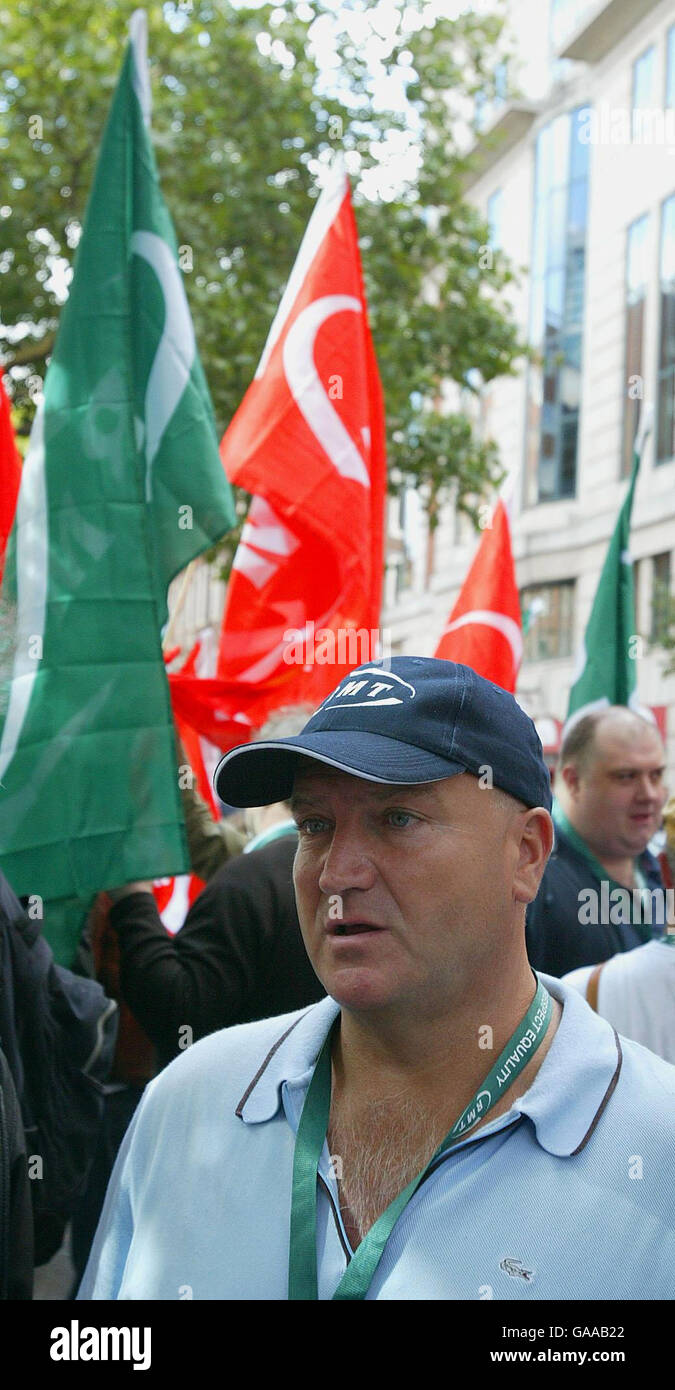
[{"x1": 79, "y1": 656, "x2": 675, "y2": 1301}]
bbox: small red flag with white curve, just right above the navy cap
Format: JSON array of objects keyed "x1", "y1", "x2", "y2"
[{"x1": 435, "y1": 500, "x2": 522, "y2": 694}]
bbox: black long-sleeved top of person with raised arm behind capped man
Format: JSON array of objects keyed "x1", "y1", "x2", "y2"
[{"x1": 110, "y1": 835, "x2": 325, "y2": 1065}]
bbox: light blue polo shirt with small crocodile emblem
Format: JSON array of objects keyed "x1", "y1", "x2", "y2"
[{"x1": 78, "y1": 976, "x2": 675, "y2": 1301}]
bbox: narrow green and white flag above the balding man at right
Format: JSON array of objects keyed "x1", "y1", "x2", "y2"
[{"x1": 565, "y1": 411, "x2": 650, "y2": 731}]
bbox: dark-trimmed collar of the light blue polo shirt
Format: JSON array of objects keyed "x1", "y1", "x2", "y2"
[{"x1": 236, "y1": 974, "x2": 621, "y2": 1158}]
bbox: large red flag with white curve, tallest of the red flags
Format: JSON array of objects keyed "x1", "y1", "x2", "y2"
[{"x1": 217, "y1": 159, "x2": 386, "y2": 727}]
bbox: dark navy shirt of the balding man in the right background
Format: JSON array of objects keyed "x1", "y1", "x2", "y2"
[{"x1": 526, "y1": 826, "x2": 663, "y2": 976}]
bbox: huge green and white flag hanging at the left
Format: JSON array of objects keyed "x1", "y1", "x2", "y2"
[{"x1": 0, "y1": 11, "x2": 233, "y2": 965}]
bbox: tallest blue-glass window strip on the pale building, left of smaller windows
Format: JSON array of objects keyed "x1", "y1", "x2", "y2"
[{"x1": 525, "y1": 107, "x2": 589, "y2": 506}]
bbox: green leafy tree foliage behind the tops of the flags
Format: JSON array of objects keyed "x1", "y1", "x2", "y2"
[{"x1": 0, "y1": 0, "x2": 522, "y2": 523}]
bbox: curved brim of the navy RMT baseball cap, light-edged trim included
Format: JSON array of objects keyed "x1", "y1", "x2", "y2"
[{"x1": 214, "y1": 730, "x2": 467, "y2": 806}]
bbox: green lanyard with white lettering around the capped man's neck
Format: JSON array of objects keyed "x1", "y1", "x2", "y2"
[{"x1": 289, "y1": 980, "x2": 553, "y2": 1301}]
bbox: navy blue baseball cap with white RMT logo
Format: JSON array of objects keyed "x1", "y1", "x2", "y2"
[{"x1": 214, "y1": 656, "x2": 551, "y2": 810}]
